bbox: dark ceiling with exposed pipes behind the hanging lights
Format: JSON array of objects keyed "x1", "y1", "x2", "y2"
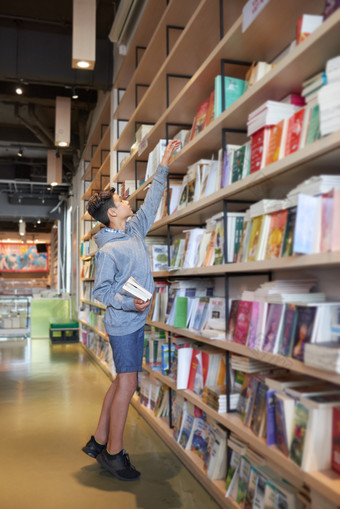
[{"x1": 0, "y1": 0, "x2": 120, "y2": 231}]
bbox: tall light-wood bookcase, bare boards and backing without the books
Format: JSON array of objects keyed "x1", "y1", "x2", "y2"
[{"x1": 81, "y1": 0, "x2": 340, "y2": 502}]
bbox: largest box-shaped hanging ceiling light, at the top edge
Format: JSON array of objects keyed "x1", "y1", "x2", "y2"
[{"x1": 72, "y1": 0, "x2": 97, "y2": 69}]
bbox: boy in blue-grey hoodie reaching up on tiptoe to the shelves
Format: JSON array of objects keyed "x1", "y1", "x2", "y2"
[{"x1": 82, "y1": 140, "x2": 180, "y2": 481}]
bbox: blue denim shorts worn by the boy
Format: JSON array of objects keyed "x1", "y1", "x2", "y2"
[{"x1": 109, "y1": 325, "x2": 144, "y2": 373}]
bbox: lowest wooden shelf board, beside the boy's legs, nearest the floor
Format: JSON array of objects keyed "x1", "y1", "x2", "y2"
[{"x1": 131, "y1": 396, "x2": 234, "y2": 509}]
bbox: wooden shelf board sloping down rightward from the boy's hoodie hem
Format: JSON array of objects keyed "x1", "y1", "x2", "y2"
[{"x1": 147, "y1": 320, "x2": 340, "y2": 384}]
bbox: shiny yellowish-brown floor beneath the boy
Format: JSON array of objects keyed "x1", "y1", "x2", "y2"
[{"x1": 0, "y1": 340, "x2": 218, "y2": 509}]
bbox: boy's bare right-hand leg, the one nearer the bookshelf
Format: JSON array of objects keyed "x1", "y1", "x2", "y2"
[{"x1": 107, "y1": 372, "x2": 137, "y2": 454}]
